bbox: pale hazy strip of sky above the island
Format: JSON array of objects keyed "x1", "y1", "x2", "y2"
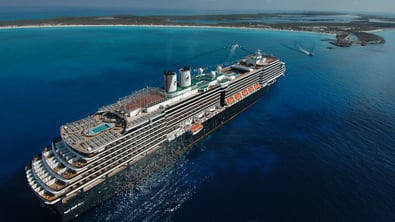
[{"x1": 0, "y1": 0, "x2": 395, "y2": 13}]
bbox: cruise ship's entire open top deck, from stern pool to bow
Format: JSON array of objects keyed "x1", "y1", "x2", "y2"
[{"x1": 60, "y1": 52, "x2": 277, "y2": 154}]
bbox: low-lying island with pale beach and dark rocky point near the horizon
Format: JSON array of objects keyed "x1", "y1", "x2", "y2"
[{"x1": 0, "y1": 12, "x2": 395, "y2": 47}]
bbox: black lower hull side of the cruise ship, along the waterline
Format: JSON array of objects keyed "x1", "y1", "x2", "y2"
[{"x1": 42, "y1": 86, "x2": 271, "y2": 221}]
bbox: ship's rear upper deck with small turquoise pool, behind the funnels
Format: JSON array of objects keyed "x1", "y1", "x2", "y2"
[{"x1": 60, "y1": 88, "x2": 165, "y2": 154}]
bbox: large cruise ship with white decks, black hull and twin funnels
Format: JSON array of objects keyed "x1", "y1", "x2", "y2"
[{"x1": 25, "y1": 51, "x2": 286, "y2": 221}]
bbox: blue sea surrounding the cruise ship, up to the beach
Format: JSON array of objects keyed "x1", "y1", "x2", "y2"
[{"x1": 0, "y1": 27, "x2": 395, "y2": 222}]
